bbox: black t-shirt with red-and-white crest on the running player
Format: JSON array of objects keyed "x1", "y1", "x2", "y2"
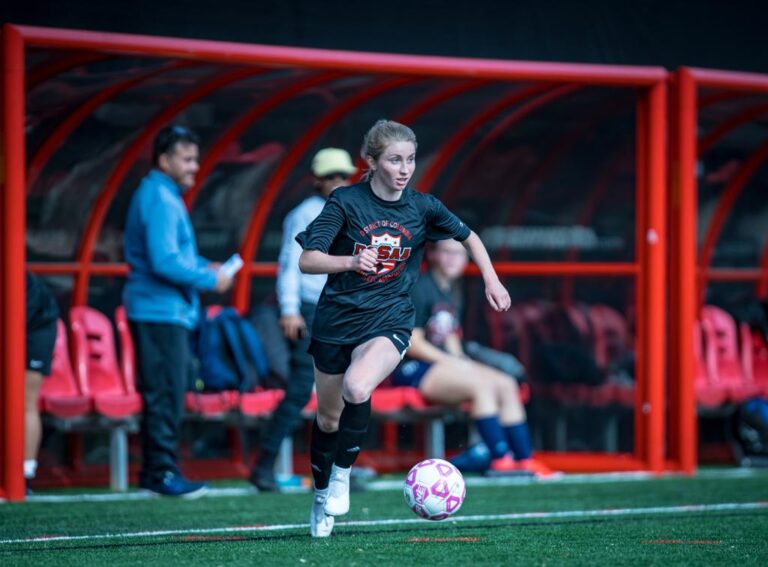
[{"x1": 296, "y1": 183, "x2": 470, "y2": 344}]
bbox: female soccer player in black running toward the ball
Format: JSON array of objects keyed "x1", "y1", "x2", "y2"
[{"x1": 296, "y1": 120, "x2": 510, "y2": 537}]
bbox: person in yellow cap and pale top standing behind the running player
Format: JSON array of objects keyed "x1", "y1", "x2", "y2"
[{"x1": 250, "y1": 148, "x2": 357, "y2": 491}]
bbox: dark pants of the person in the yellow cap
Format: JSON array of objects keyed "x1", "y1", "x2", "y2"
[{"x1": 261, "y1": 303, "x2": 316, "y2": 464}]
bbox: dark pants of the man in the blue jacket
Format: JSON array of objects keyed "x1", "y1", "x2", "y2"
[{"x1": 130, "y1": 321, "x2": 190, "y2": 483}]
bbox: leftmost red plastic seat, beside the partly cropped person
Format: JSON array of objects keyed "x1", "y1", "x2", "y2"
[{"x1": 39, "y1": 319, "x2": 92, "y2": 419}]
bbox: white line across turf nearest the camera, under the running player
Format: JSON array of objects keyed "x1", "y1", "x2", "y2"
[{"x1": 0, "y1": 502, "x2": 768, "y2": 545}]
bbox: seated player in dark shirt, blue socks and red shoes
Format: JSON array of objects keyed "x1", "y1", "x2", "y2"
[{"x1": 392, "y1": 240, "x2": 552, "y2": 477}]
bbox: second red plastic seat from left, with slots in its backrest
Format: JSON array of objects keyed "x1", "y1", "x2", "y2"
[{"x1": 69, "y1": 307, "x2": 141, "y2": 419}]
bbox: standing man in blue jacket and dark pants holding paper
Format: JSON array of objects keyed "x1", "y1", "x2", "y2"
[{"x1": 123, "y1": 126, "x2": 232, "y2": 498}]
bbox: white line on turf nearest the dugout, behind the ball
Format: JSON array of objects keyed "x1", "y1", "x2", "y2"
[{"x1": 13, "y1": 468, "x2": 768, "y2": 504}]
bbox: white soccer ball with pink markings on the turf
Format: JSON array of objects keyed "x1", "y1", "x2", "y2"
[{"x1": 403, "y1": 459, "x2": 467, "y2": 520}]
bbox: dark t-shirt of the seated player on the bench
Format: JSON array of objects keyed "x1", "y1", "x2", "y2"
[{"x1": 411, "y1": 272, "x2": 463, "y2": 349}]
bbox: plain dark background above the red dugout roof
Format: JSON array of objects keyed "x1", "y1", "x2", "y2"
[{"x1": 0, "y1": 0, "x2": 768, "y2": 72}]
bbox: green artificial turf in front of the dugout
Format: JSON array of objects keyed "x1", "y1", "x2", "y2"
[{"x1": 0, "y1": 474, "x2": 768, "y2": 567}]
